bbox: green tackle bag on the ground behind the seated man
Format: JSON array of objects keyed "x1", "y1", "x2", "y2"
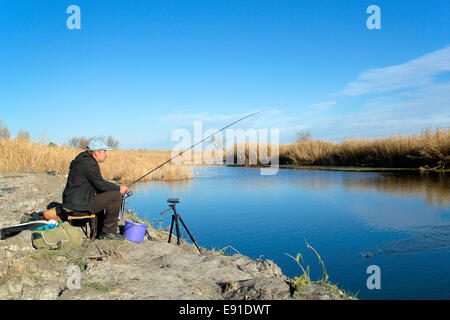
[{"x1": 31, "y1": 222, "x2": 83, "y2": 249}]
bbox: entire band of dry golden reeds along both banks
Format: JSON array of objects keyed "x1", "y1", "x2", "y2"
[{"x1": 0, "y1": 128, "x2": 450, "y2": 181}]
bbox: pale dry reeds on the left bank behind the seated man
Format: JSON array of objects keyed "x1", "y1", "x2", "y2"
[{"x1": 0, "y1": 138, "x2": 193, "y2": 182}]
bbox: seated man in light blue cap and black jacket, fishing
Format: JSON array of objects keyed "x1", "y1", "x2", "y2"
[{"x1": 62, "y1": 139, "x2": 128, "y2": 240}]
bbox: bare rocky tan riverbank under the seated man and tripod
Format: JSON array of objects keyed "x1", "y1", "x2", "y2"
[{"x1": 0, "y1": 172, "x2": 347, "y2": 300}]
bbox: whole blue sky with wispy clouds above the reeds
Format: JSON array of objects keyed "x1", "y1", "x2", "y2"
[{"x1": 0, "y1": 0, "x2": 450, "y2": 149}]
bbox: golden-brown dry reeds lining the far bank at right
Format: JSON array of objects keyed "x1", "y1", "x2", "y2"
[{"x1": 222, "y1": 128, "x2": 450, "y2": 170}]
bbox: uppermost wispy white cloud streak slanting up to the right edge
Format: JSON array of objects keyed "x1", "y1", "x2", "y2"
[{"x1": 341, "y1": 46, "x2": 450, "y2": 96}]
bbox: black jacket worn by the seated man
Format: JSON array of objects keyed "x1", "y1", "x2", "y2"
[{"x1": 62, "y1": 151, "x2": 120, "y2": 212}]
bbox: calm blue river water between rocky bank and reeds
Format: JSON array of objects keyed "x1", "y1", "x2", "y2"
[{"x1": 127, "y1": 167, "x2": 450, "y2": 299}]
